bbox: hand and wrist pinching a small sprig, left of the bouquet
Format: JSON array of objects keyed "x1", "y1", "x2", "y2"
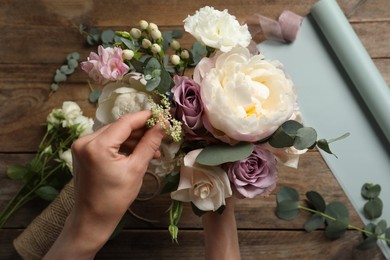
[{"x1": 45, "y1": 111, "x2": 164, "y2": 259}]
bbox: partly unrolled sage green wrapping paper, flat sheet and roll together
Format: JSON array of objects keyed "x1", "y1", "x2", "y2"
[{"x1": 258, "y1": 0, "x2": 390, "y2": 259}]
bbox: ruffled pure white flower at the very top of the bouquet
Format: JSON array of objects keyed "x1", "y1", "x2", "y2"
[{"x1": 184, "y1": 6, "x2": 252, "y2": 52}]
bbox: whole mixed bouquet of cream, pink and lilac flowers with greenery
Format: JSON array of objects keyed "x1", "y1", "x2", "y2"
[{"x1": 81, "y1": 6, "x2": 340, "y2": 240}]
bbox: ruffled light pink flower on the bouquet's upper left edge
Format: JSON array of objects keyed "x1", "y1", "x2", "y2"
[{"x1": 81, "y1": 45, "x2": 129, "y2": 84}]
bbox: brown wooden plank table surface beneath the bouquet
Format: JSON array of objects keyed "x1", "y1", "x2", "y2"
[{"x1": 0, "y1": 0, "x2": 390, "y2": 259}]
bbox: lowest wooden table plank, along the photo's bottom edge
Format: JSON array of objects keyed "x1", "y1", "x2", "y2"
[{"x1": 0, "y1": 230, "x2": 384, "y2": 260}]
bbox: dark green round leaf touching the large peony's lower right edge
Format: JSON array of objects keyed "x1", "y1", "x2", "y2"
[{"x1": 268, "y1": 120, "x2": 303, "y2": 148}]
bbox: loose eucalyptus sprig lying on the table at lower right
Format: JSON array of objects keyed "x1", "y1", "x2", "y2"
[{"x1": 276, "y1": 184, "x2": 390, "y2": 250}]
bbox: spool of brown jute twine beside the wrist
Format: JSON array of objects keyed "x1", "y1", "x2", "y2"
[{"x1": 14, "y1": 181, "x2": 74, "y2": 260}]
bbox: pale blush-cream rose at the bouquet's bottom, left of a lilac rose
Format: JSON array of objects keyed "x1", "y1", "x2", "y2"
[{"x1": 171, "y1": 149, "x2": 232, "y2": 211}]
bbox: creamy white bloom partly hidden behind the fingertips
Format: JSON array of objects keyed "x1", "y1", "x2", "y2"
[{"x1": 96, "y1": 73, "x2": 151, "y2": 125}]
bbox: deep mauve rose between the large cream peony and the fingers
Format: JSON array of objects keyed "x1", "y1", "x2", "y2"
[{"x1": 172, "y1": 75, "x2": 203, "y2": 135}]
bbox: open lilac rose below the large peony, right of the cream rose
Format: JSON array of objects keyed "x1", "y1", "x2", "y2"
[{"x1": 225, "y1": 145, "x2": 277, "y2": 198}]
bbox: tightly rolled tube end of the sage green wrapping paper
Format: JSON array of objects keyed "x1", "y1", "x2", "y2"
[{"x1": 311, "y1": 0, "x2": 390, "y2": 142}]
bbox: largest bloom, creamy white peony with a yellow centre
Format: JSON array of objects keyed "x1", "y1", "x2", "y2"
[{"x1": 194, "y1": 48, "x2": 296, "y2": 143}]
